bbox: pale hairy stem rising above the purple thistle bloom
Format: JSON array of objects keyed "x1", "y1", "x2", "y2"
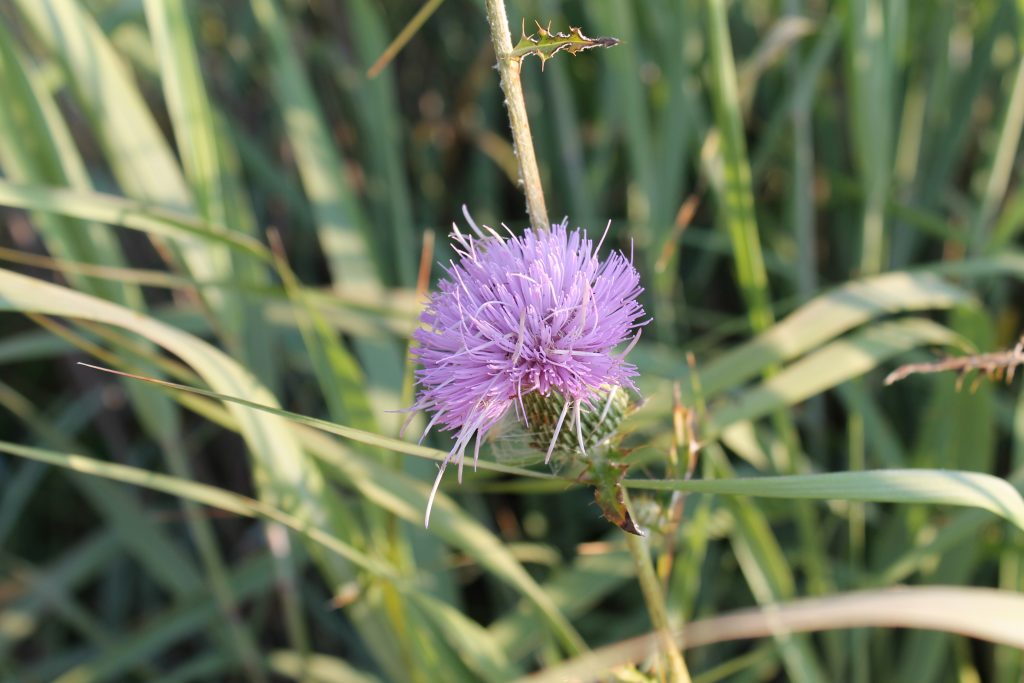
[{"x1": 486, "y1": 0, "x2": 551, "y2": 230}]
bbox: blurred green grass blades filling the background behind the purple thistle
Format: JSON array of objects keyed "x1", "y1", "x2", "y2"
[{"x1": 0, "y1": 0, "x2": 1024, "y2": 683}]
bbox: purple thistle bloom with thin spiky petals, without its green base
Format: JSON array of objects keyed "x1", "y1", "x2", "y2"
[{"x1": 411, "y1": 214, "x2": 644, "y2": 524}]
